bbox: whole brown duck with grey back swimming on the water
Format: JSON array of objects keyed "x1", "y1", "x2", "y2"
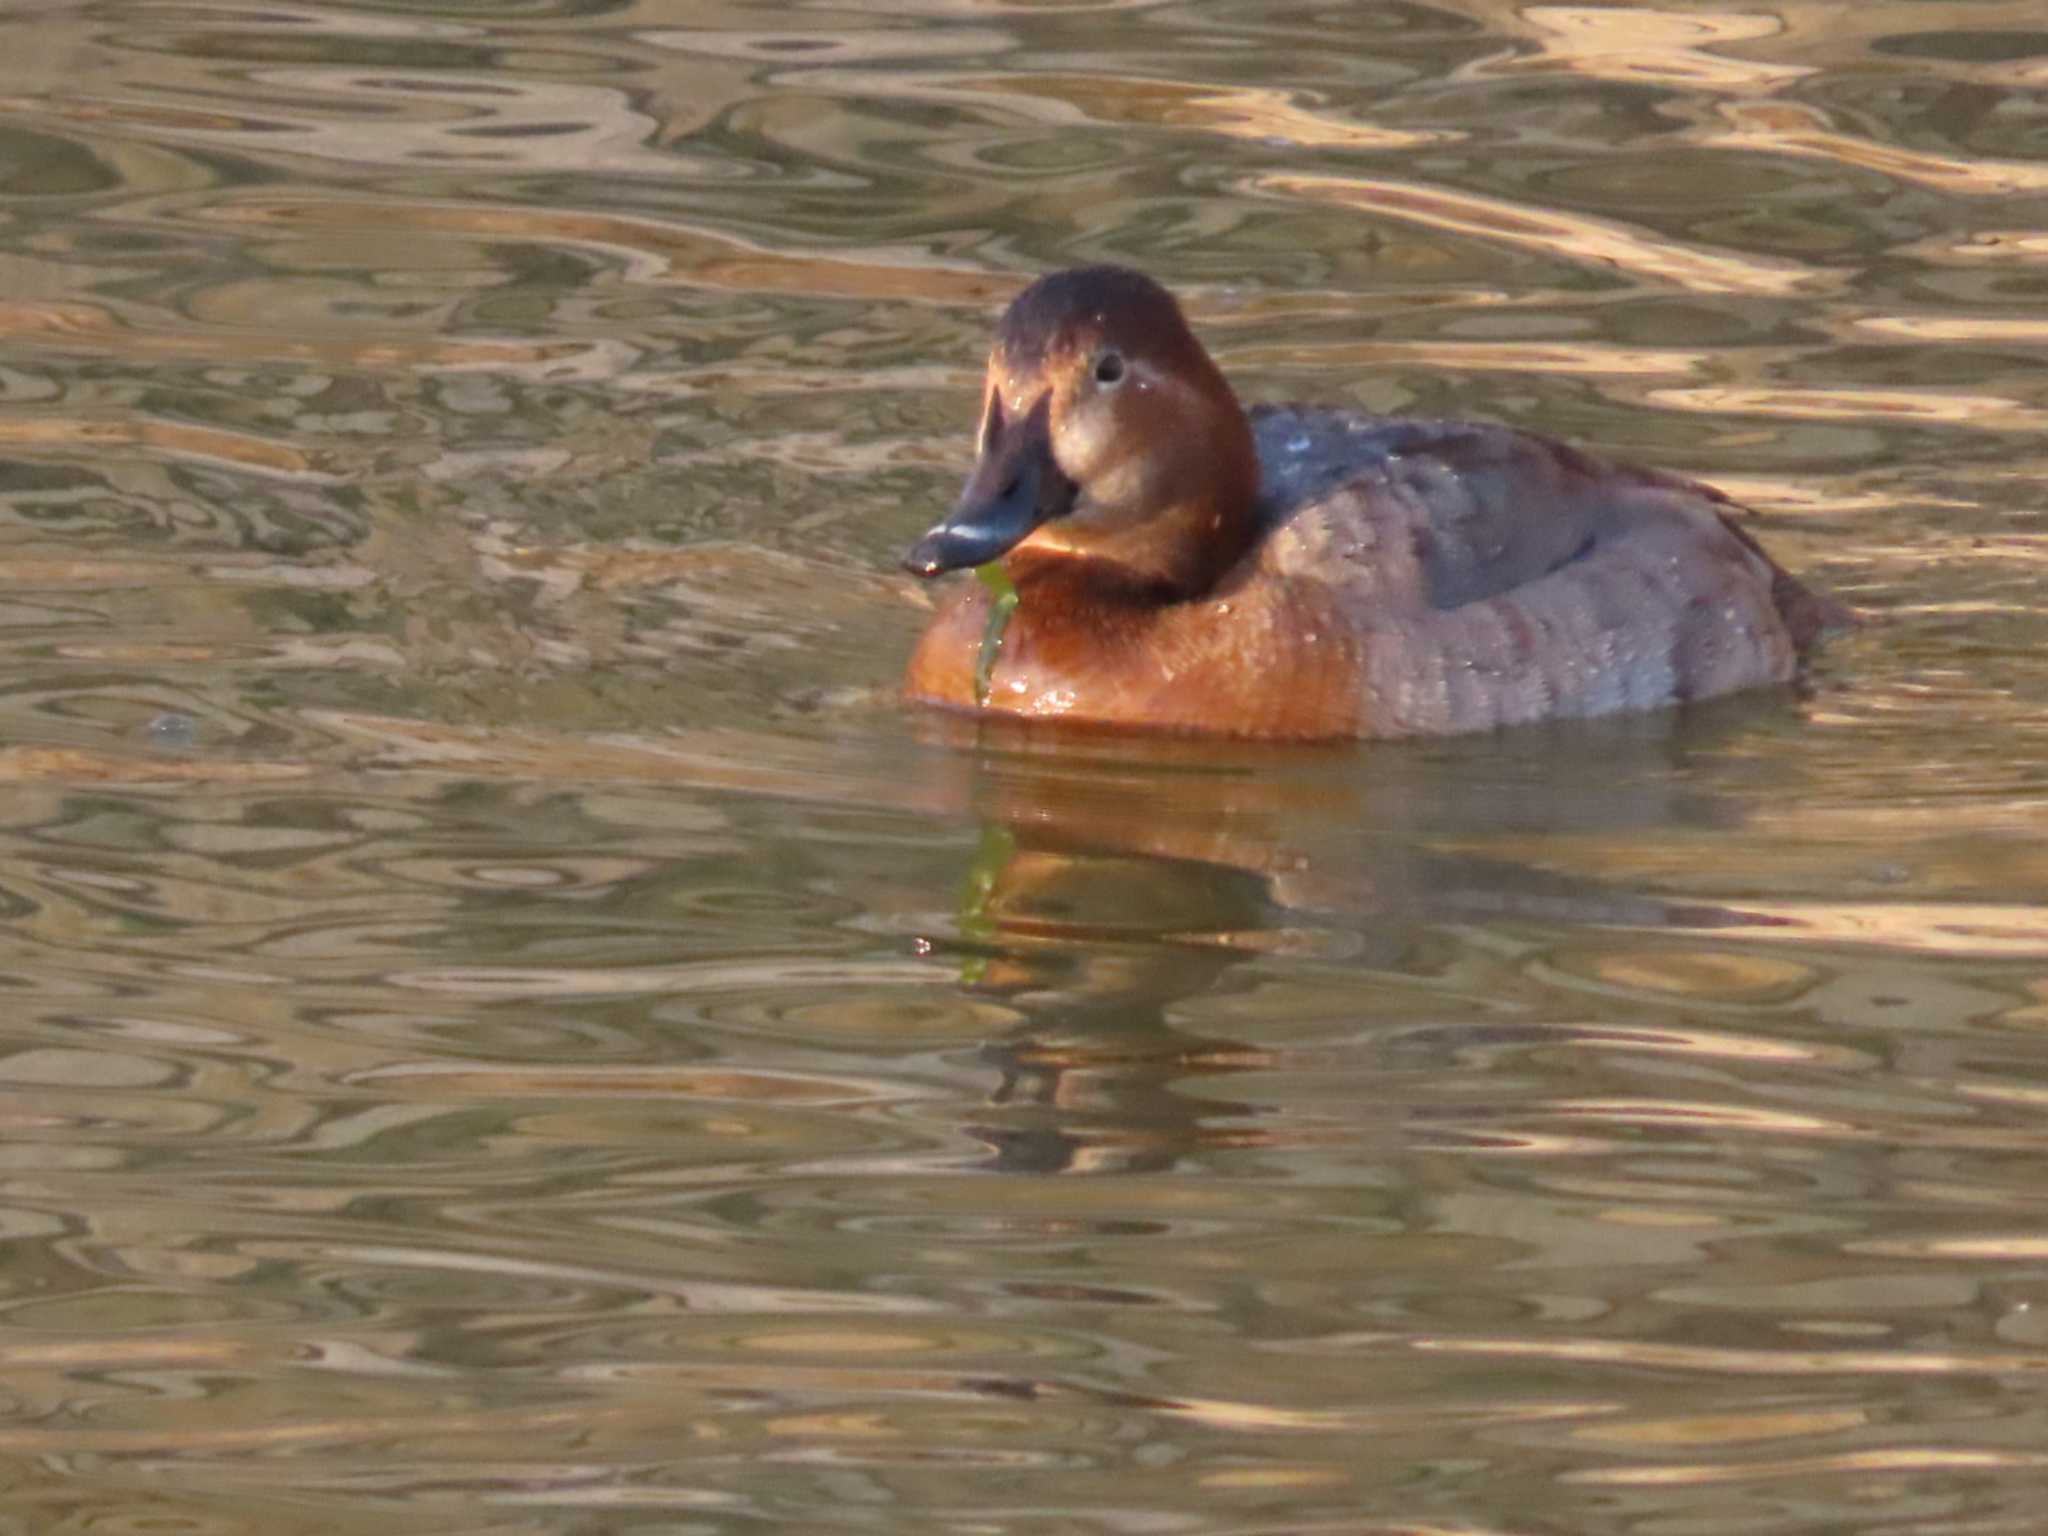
[{"x1": 903, "y1": 266, "x2": 1849, "y2": 741}]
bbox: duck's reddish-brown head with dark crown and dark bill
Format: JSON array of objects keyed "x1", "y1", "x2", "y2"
[{"x1": 903, "y1": 266, "x2": 1260, "y2": 600}]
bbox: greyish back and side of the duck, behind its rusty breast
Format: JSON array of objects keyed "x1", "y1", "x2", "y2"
[{"x1": 1219, "y1": 406, "x2": 1845, "y2": 735}]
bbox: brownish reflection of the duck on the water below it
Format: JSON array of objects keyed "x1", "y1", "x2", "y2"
[{"x1": 909, "y1": 700, "x2": 1792, "y2": 1174}]
